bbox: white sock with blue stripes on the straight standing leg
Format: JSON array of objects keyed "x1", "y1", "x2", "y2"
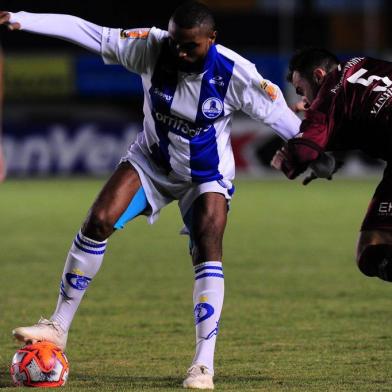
[{"x1": 193, "y1": 261, "x2": 225, "y2": 372}]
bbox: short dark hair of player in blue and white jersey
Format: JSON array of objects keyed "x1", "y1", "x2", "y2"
[{"x1": 171, "y1": 1, "x2": 215, "y2": 31}]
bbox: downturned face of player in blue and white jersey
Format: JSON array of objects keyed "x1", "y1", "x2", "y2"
[{"x1": 169, "y1": 20, "x2": 216, "y2": 72}]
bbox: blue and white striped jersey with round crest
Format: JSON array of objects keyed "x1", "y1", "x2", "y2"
[{"x1": 101, "y1": 27, "x2": 300, "y2": 183}]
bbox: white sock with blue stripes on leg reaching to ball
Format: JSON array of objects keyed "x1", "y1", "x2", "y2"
[{"x1": 50, "y1": 231, "x2": 107, "y2": 332}]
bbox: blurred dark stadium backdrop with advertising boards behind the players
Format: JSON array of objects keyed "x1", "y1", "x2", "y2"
[{"x1": 0, "y1": 0, "x2": 392, "y2": 178}]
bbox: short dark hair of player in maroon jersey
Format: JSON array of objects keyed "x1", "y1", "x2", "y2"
[{"x1": 287, "y1": 47, "x2": 339, "y2": 82}]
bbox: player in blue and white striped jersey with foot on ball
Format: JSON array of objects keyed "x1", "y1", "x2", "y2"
[{"x1": 0, "y1": 1, "x2": 300, "y2": 389}]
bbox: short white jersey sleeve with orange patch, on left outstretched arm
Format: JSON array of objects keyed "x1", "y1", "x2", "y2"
[{"x1": 102, "y1": 27, "x2": 167, "y2": 74}]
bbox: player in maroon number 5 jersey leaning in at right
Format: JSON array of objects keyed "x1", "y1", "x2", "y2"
[{"x1": 272, "y1": 48, "x2": 392, "y2": 288}]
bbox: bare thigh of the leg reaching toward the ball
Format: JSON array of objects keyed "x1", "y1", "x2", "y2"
[{"x1": 87, "y1": 162, "x2": 141, "y2": 226}]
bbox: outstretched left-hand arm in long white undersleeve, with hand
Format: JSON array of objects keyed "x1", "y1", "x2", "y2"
[{"x1": 0, "y1": 11, "x2": 103, "y2": 53}]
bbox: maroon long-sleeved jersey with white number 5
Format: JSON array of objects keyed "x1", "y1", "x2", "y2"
[{"x1": 282, "y1": 57, "x2": 392, "y2": 178}]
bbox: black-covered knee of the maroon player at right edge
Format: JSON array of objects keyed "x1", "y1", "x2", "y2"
[{"x1": 357, "y1": 244, "x2": 392, "y2": 282}]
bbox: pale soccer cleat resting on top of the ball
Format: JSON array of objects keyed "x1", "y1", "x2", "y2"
[{"x1": 12, "y1": 317, "x2": 68, "y2": 351}]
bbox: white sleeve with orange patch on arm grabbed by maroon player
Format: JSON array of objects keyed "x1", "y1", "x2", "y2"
[{"x1": 233, "y1": 63, "x2": 301, "y2": 140}]
